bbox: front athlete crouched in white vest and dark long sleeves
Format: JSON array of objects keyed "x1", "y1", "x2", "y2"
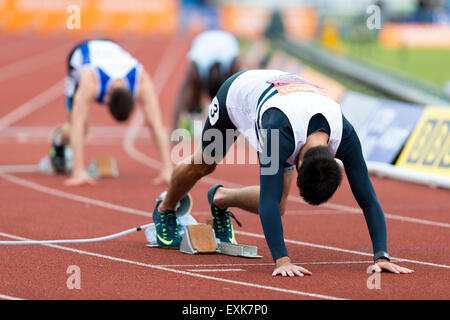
[{"x1": 153, "y1": 70, "x2": 412, "y2": 276}]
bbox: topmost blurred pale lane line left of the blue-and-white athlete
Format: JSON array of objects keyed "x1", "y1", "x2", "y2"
[{"x1": 0, "y1": 44, "x2": 71, "y2": 82}]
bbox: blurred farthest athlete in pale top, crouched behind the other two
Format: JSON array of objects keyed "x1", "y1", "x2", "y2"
[{"x1": 173, "y1": 30, "x2": 240, "y2": 134}]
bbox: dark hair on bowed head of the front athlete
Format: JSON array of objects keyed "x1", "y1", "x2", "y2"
[{"x1": 297, "y1": 146, "x2": 342, "y2": 205}]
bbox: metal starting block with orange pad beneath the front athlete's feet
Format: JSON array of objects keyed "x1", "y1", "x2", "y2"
[{"x1": 180, "y1": 224, "x2": 262, "y2": 258}]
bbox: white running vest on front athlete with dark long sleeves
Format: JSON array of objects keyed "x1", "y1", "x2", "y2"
[{"x1": 226, "y1": 70, "x2": 343, "y2": 164}]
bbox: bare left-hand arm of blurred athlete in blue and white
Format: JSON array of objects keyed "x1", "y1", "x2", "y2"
[{"x1": 65, "y1": 69, "x2": 97, "y2": 186}]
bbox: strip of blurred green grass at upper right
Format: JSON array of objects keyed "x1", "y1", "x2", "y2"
[{"x1": 343, "y1": 41, "x2": 450, "y2": 88}]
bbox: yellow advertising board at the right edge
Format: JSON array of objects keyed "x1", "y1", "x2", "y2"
[{"x1": 396, "y1": 107, "x2": 450, "y2": 176}]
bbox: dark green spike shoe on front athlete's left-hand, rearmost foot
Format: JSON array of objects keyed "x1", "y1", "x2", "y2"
[{"x1": 153, "y1": 200, "x2": 181, "y2": 249}]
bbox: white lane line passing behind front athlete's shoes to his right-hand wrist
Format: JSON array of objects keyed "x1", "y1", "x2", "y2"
[{"x1": 0, "y1": 172, "x2": 450, "y2": 269}]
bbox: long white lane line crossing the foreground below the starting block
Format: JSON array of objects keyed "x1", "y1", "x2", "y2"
[{"x1": 0, "y1": 232, "x2": 345, "y2": 300}]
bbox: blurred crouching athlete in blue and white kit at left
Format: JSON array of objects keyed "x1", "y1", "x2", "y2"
[{"x1": 50, "y1": 40, "x2": 172, "y2": 186}]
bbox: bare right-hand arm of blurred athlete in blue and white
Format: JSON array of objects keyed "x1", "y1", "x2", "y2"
[{"x1": 138, "y1": 70, "x2": 173, "y2": 184}]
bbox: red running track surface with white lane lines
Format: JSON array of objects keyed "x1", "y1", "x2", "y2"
[{"x1": 0, "y1": 37, "x2": 450, "y2": 300}]
